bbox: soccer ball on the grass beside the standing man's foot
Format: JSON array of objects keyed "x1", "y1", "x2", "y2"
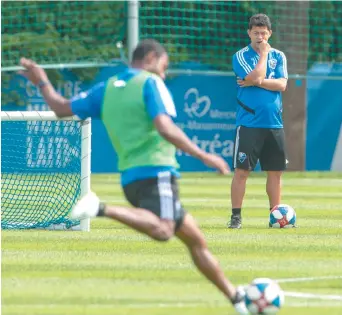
[{"x1": 269, "y1": 205, "x2": 296, "y2": 228}]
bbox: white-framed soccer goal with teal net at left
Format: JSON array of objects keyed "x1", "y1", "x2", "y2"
[{"x1": 1, "y1": 111, "x2": 91, "y2": 231}]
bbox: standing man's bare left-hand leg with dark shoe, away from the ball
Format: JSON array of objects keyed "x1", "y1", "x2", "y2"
[{"x1": 228, "y1": 168, "x2": 249, "y2": 229}]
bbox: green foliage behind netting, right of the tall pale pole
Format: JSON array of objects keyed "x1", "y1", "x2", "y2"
[{"x1": 140, "y1": 1, "x2": 342, "y2": 71}]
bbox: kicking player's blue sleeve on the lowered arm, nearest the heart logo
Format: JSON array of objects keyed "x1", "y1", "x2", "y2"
[{"x1": 144, "y1": 78, "x2": 167, "y2": 120}]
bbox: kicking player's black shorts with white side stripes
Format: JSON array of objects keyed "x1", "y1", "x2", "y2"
[{"x1": 123, "y1": 172, "x2": 185, "y2": 230}]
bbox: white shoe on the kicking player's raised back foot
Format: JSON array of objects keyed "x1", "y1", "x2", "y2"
[{"x1": 70, "y1": 191, "x2": 100, "y2": 219}]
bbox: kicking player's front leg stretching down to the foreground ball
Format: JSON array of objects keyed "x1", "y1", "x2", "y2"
[{"x1": 176, "y1": 213, "x2": 248, "y2": 314}]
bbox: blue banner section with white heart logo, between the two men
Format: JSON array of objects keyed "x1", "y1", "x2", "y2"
[{"x1": 166, "y1": 75, "x2": 236, "y2": 171}]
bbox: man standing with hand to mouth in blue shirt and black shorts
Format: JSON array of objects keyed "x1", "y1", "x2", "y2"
[{"x1": 228, "y1": 14, "x2": 288, "y2": 229}]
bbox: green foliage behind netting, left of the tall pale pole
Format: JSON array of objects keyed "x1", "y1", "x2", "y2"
[{"x1": 1, "y1": 1, "x2": 126, "y2": 105}]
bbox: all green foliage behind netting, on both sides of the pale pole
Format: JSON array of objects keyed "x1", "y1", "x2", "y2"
[{"x1": 1, "y1": 1, "x2": 342, "y2": 104}]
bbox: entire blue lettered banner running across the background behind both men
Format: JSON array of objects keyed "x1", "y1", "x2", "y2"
[{"x1": 2, "y1": 64, "x2": 342, "y2": 173}]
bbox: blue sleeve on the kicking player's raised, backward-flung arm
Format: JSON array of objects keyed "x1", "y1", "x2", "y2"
[{"x1": 71, "y1": 82, "x2": 106, "y2": 119}]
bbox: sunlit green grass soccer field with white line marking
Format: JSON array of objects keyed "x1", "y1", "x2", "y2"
[{"x1": 2, "y1": 172, "x2": 342, "y2": 315}]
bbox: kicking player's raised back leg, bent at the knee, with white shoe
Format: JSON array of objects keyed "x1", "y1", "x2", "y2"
[{"x1": 70, "y1": 192, "x2": 175, "y2": 241}]
